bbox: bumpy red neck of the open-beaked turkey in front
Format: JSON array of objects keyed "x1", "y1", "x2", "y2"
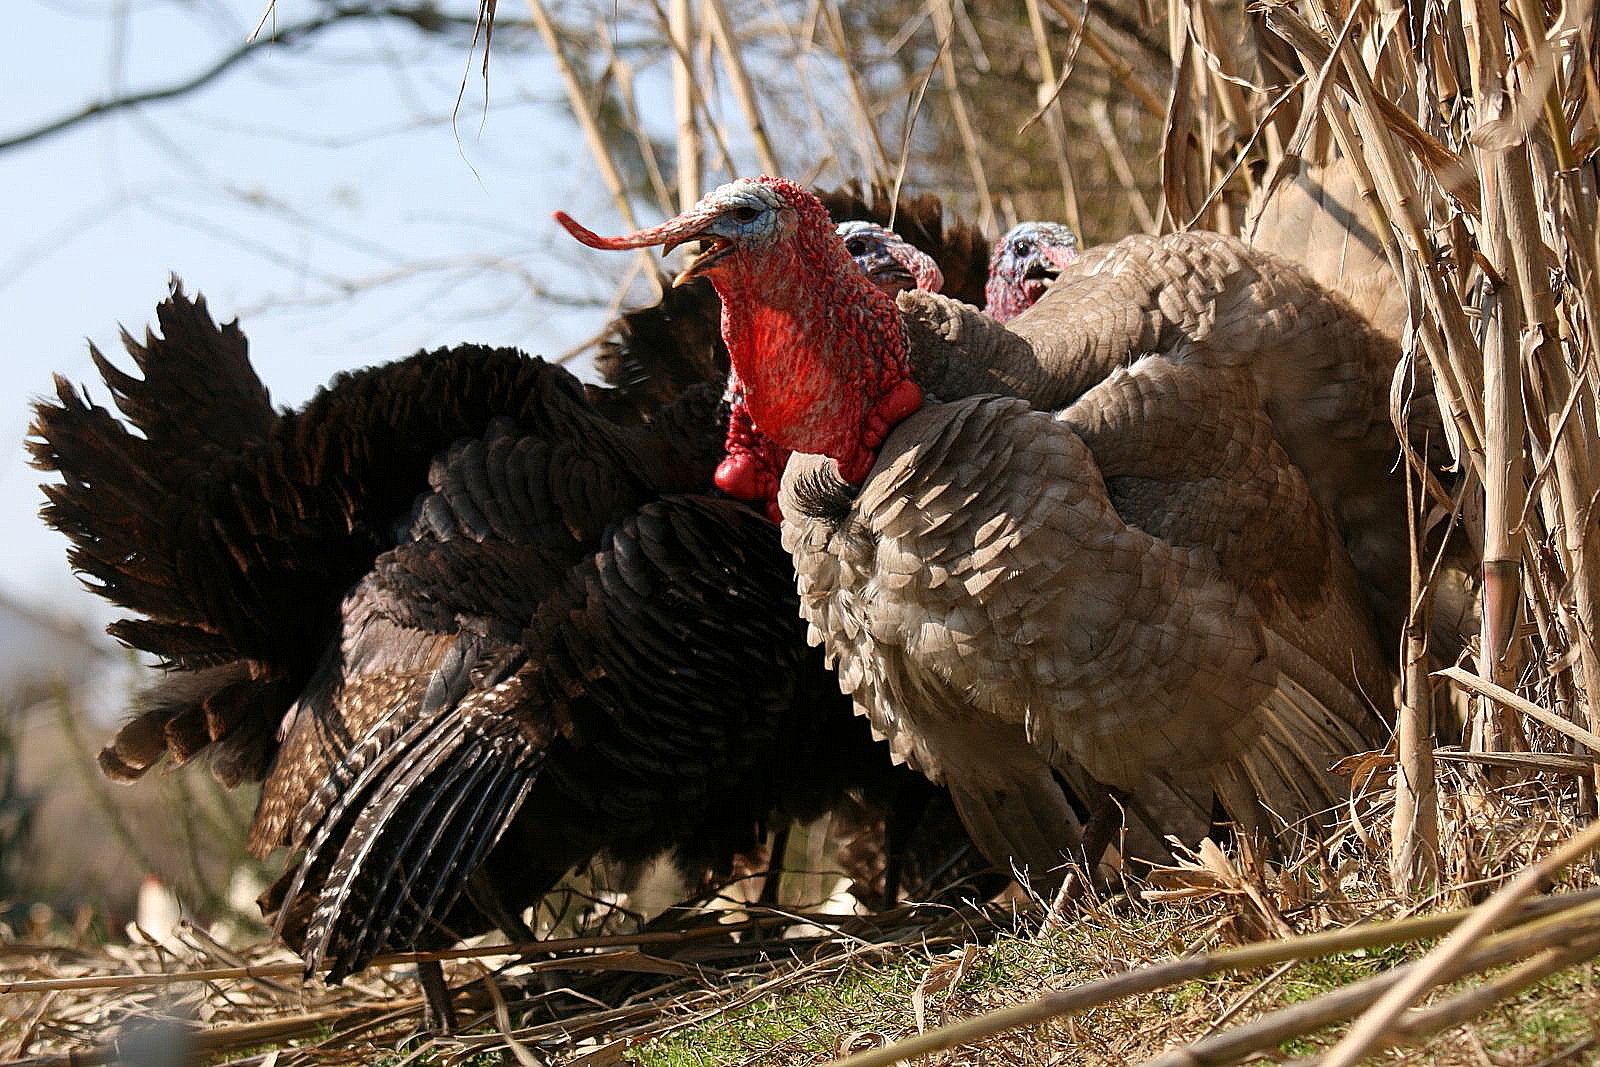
[{"x1": 714, "y1": 246, "x2": 922, "y2": 483}]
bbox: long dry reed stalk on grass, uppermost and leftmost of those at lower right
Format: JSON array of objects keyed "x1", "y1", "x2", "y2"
[{"x1": 829, "y1": 895, "x2": 1600, "y2": 1067}]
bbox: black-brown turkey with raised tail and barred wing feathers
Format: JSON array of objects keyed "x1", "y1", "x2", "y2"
[{"x1": 30, "y1": 271, "x2": 985, "y2": 1017}]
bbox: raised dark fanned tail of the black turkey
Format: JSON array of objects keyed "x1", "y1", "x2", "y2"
[{"x1": 27, "y1": 278, "x2": 285, "y2": 784}]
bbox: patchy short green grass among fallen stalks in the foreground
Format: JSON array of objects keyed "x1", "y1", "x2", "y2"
[{"x1": 629, "y1": 913, "x2": 1600, "y2": 1067}]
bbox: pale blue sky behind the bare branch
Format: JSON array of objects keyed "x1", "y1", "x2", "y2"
[{"x1": 0, "y1": 0, "x2": 649, "y2": 633}]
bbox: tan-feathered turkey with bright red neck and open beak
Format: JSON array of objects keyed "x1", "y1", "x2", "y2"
[{"x1": 557, "y1": 178, "x2": 1420, "y2": 870}]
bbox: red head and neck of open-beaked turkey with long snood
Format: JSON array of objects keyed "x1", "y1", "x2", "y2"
[{"x1": 555, "y1": 178, "x2": 922, "y2": 499}]
